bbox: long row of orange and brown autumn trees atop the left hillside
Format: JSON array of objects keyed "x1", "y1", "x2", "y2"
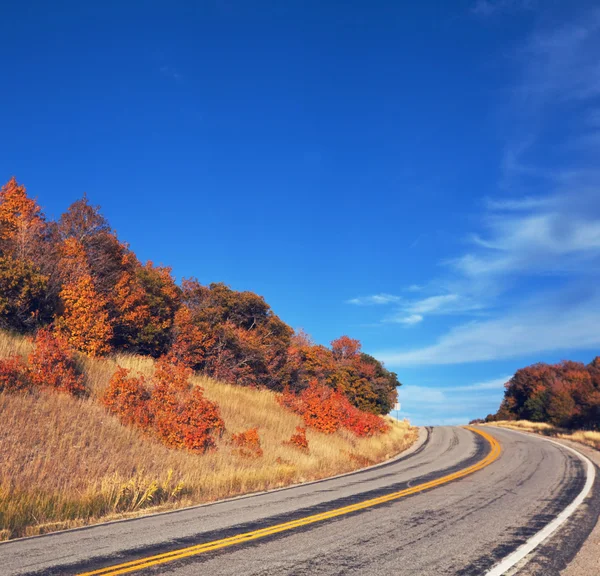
[{"x1": 0, "y1": 178, "x2": 400, "y2": 414}]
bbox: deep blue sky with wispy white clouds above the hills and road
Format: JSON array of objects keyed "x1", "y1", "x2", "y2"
[{"x1": 0, "y1": 0, "x2": 600, "y2": 424}]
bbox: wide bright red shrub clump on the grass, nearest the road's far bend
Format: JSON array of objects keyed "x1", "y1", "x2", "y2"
[{"x1": 280, "y1": 380, "x2": 389, "y2": 436}]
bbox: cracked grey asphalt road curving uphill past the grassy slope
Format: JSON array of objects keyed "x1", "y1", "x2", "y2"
[{"x1": 0, "y1": 427, "x2": 600, "y2": 576}]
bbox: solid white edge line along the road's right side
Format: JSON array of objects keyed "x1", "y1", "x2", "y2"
[{"x1": 485, "y1": 428, "x2": 596, "y2": 576}]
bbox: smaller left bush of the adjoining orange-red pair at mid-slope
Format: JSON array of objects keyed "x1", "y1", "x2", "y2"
[{"x1": 101, "y1": 367, "x2": 152, "y2": 428}]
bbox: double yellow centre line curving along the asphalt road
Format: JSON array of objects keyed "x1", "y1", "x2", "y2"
[{"x1": 79, "y1": 427, "x2": 501, "y2": 576}]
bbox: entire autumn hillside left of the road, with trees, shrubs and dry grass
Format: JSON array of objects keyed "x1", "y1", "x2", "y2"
[{"x1": 0, "y1": 179, "x2": 417, "y2": 539}]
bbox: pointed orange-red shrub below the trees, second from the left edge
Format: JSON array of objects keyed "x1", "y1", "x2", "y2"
[{"x1": 29, "y1": 328, "x2": 86, "y2": 396}]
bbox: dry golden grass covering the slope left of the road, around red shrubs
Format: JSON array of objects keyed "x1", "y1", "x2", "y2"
[{"x1": 0, "y1": 333, "x2": 417, "y2": 540}]
